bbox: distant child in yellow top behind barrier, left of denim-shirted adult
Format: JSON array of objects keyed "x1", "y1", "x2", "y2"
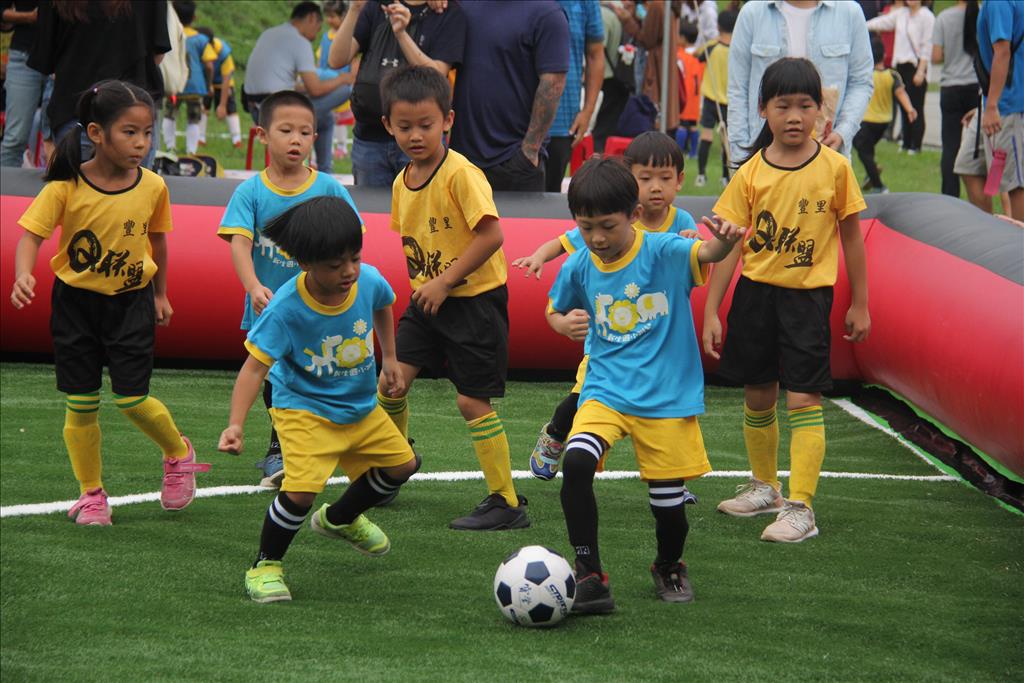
[{"x1": 695, "y1": 9, "x2": 736, "y2": 187}]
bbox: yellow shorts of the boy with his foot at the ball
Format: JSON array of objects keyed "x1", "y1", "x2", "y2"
[{"x1": 569, "y1": 399, "x2": 711, "y2": 481}]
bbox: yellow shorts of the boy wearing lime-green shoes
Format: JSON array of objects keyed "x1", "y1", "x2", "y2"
[{"x1": 270, "y1": 405, "x2": 415, "y2": 494}]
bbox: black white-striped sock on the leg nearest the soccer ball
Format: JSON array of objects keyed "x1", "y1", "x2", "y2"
[{"x1": 561, "y1": 433, "x2": 604, "y2": 575}]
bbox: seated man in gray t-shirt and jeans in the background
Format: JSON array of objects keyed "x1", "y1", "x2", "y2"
[{"x1": 244, "y1": 2, "x2": 354, "y2": 173}]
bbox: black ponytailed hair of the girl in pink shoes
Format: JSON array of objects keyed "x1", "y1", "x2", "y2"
[{"x1": 43, "y1": 80, "x2": 154, "y2": 181}]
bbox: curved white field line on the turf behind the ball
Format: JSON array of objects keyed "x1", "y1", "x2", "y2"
[{"x1": 0, "y1": 470, "x2": 956, "y2": 518}]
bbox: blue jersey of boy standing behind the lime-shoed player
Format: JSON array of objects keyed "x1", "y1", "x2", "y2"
[{"x1": 217, "y1": 170, "x2": 362, "y2": 330}]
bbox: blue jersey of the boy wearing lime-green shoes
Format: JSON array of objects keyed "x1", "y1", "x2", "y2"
[{"x1": 246, "y1": 264, "x2": 394, "y2": 424}]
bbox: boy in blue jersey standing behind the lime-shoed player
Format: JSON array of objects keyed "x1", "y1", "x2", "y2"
[{"x1": 217, "y1": 90, "x2": 361, "y2": 488}]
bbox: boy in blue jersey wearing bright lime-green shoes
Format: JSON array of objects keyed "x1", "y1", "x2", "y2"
[{"x1": 218, "y1": 197, "x2": 418, "y2": 602}]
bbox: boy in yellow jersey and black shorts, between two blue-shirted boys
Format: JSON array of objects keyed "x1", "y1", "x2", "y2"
[{"x1": 378, "y1": 67, "x2": 529, "y2": 531}]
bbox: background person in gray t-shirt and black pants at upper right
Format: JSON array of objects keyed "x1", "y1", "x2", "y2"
[{"x1": 932, "y1": 1, "x2": 979, "y2": 197}]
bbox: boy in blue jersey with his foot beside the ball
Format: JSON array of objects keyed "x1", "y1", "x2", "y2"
[{"x1": 548, "y1": 159, "x2": 742, "y2": 613}]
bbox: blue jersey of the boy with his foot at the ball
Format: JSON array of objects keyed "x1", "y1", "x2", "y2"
[{"x1": 550, "y1": 230, "x2": 705, "y2": 418}]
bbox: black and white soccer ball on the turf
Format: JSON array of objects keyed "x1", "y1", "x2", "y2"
[{"x1": 495, "y1": 546, "x2": 575, "y2": 627}]
